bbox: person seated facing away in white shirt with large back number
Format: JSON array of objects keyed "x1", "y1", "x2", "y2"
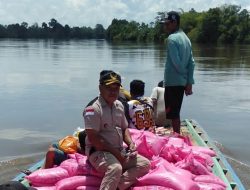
[{"x1": 128, "y1": 80, "x2": 155, "y2": 132}]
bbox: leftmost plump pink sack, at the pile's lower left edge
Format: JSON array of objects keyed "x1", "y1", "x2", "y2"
[{"x1": 25, "y1": 167, "x2": 69, "y2": 187}]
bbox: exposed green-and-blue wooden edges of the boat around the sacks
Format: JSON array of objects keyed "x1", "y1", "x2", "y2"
[{"x1": 13, "y1": 119, "x2": 245, "y2": 190}]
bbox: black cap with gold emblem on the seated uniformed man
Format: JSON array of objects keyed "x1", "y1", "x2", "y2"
[{"x1": 99, "y1": 70, "x2": 121, "y2": 86}]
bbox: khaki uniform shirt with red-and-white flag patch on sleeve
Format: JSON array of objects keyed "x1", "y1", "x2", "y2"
[{"x1": 83, "y1": 96, "x2": 128, "y2": 155}]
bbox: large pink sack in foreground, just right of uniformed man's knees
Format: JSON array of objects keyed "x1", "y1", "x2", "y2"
[{"x1": 135, "y1": 165, "x2": 199, "y2": 190}]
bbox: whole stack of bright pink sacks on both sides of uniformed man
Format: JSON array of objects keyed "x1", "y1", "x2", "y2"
[{"x1": 26, "y1": 129, "x2": 226, "y2": 190}]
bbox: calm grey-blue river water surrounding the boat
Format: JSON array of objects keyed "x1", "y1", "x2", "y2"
[{"x1": 0, "y1": 40, "x2": 250, "y2": 186}]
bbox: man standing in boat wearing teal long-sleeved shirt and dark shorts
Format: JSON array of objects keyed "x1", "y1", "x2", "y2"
[{"x1": 162, "y1": 11, "x2": 195, "y2": 133}]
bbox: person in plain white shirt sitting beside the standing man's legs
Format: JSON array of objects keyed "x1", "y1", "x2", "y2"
[{"x1": 150, "y1": 80, "x2": 171, "y2": 127}]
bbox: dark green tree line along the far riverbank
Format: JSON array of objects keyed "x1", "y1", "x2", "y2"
[{"x1": 0, "y1": 4, "x2": 250, "y2": 43}]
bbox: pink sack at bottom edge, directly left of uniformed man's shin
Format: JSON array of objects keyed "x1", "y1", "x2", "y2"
[{"x1": 56, "y1": 176, "x2": 102, "y2": 190}]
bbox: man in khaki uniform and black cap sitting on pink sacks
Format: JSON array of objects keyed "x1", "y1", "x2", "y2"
[{"x1": 83, "y1": 70, "x2": 150, "y2": 190}]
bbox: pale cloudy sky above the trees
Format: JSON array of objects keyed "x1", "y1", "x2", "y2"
[{"x1": 0, "y1": 0, "x2": 250, "y2": 28}]
